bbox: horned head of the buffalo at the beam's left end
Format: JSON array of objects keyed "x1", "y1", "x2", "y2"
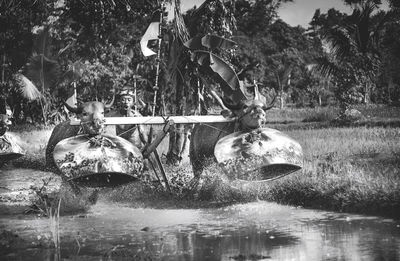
[{"x1": 64, "y1": 98, "x2": 114, "y2": 135}]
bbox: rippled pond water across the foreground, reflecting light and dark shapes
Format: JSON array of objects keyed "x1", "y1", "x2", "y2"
[{"x1": 0, "y1": 202, "x2": 400, "y2": 260}]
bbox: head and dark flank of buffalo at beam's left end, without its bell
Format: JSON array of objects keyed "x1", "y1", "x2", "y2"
[{"x1": 46, "y1": 99, "x2": 114, "y2": 171}]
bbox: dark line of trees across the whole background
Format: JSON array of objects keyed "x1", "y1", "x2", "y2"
[{"x1": 0, "y1": 0, "x2": 400, "y2": 123}]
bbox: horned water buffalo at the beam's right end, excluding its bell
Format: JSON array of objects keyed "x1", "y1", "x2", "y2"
[{"x1": 189, "y1": 92, "x2": 275, "y2": 182}]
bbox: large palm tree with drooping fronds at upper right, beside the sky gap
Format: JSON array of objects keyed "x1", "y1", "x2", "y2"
[{"x1": 311, "y1": 0, "x2": 388, "y2": 107}]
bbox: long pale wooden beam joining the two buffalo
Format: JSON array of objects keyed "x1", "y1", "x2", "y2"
[{"x1": 71, "y1": 115, "x2": 235, "y2": 125}]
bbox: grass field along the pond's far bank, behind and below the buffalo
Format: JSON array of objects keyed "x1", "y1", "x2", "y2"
[{"x1": 6, "y1": 106, "x2": 400, "y2": 218}]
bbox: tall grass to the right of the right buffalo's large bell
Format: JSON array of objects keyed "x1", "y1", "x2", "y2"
[{"x1": 262, "y1": 128, "x2": 400, "y2": 217}]
